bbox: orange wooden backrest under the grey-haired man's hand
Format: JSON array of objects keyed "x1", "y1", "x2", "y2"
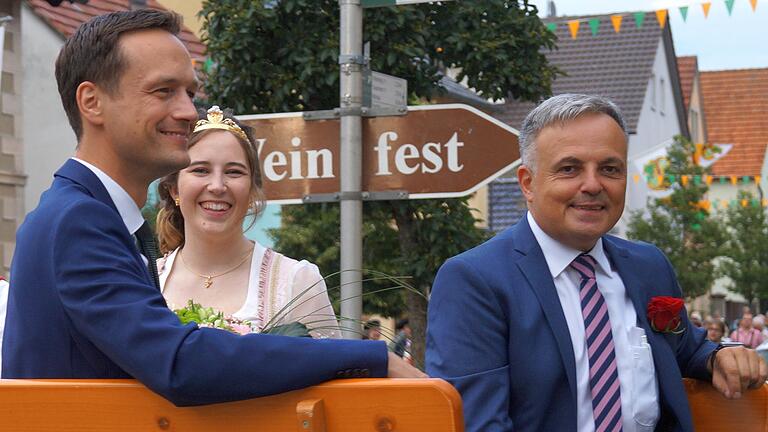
[{"x1": 684, "y1": 379, "x2": 768, "y2": 432}]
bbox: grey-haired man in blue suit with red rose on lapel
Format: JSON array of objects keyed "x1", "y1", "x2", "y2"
[{"x1": 427, "y1": 95, "x2": 766, "y2": 432}]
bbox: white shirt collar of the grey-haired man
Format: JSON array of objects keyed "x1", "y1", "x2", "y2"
[{"x1": 526, "y1": 212, "x2": 613, "y2": 279}]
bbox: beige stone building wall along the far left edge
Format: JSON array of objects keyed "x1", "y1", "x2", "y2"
[{"x1": 0, "y1": 0, "x2": 25, "y2": 276}]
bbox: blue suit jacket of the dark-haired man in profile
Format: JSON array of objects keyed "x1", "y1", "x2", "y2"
[{"x1": 2, "y1": 160, "x2": 387, "y2": 405}]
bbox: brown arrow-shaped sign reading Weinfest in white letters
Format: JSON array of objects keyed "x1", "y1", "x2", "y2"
[{"x1": 239, "y1": 104, "x2": 519, "y2": 203}]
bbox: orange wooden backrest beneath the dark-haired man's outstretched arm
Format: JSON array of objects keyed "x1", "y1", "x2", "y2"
[{"x1": 0, "y1": 379, "x2": 464, "y2": 432}]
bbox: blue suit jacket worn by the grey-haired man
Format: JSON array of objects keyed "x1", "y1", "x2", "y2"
[{"x1": 426, "y1": 217, "x2": 715, "y2": 432}]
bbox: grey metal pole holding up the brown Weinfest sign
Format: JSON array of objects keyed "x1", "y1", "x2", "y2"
[{"x1": 339, "y1": 0, "x2": 365, "y2": 339}]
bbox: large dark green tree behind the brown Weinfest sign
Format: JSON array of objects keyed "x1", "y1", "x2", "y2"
[{"x1": 201, "y1": 0, "x2": 558, "y2": 361}]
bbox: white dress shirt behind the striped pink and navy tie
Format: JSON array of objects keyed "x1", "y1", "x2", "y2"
[{"x1": 526, "y1": 212, "x2": 659, "y2": 432}]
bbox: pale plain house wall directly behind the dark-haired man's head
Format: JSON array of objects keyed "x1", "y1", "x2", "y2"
[{"x1": 21, "y1": 5, "x2": 77, "y2": 213}]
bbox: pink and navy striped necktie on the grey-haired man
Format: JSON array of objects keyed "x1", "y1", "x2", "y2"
[{"x1": 571, "y1": 254, "x2": 622, "y2": 432}]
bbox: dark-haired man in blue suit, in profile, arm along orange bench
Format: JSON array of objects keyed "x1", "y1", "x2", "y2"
[{"x1": 2, "y1": 9, "x2": 424, "y2": 405}]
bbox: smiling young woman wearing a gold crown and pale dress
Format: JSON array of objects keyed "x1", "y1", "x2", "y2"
[{"x1": 157, "y1": 105, "x2": 340, "y2": 337}]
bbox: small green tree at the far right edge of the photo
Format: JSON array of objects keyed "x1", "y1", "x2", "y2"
[{"x1": 719, "y1": 191, "x2": 768, "y2": 310}]
